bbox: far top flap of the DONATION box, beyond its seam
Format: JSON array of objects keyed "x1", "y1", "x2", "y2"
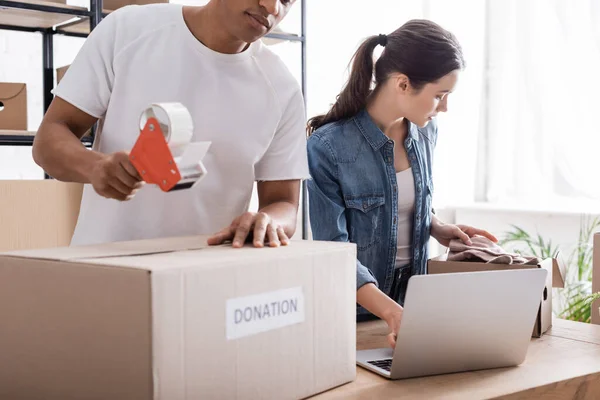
[{"x1": 0, "y1": 236, "x2": 208, "y2": 264}]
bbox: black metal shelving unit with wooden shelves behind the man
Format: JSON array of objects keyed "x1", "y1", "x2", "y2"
[{"x1": 0, "y1": 0, "x2": 308, "y2": 239}]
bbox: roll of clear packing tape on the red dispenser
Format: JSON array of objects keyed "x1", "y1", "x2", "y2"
[{"x1": 140, "y1": 103, "x2": 194, "y2": 153}]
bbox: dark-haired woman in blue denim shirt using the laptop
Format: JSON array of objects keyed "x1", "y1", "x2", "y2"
[{"x1": 308, "y1": 20, "x2": 497, "y2": 346}]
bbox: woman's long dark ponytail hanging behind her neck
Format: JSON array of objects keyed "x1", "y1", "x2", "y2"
[{"x1": 307, "y1": 35, "x2": 385, "y2": 135}]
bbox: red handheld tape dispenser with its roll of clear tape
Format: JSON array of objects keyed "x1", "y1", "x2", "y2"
[{"x1": 129, "y1": 103, "x2": 210, "y2": 192}]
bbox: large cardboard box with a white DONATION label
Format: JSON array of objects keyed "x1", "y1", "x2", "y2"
[{"x1": 0, "y1": 236, "x2": 356, "y2": 400}]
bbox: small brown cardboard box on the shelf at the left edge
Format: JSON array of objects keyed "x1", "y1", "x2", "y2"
[{"x1": 0, "y1": 82, "x2": 27, "y2": 131}]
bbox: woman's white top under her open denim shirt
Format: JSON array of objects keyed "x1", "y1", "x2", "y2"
[{"x1": 396, "y1": 168, "x2": 415, "y2": 268}]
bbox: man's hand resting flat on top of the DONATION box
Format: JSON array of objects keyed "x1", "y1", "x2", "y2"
[{"x1": 208, "y1": 212, "x2": 290, "y2": 248}]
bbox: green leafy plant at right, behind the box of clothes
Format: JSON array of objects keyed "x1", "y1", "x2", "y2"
[{"x1": 500, "y1": 216, "x2": 600, "y2": 322}]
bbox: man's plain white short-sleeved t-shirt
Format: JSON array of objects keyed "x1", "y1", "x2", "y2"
[{"x1": 54, "y1": 4, "x2": 309, "y2": 245}]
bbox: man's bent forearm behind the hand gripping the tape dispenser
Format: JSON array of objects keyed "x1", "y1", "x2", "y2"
[{"x1": 33, "y1": 123, "x2": 104, "y2": 183}]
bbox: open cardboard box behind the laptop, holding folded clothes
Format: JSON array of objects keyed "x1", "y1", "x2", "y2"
[{"x1": 427, "y1": 253, "x2": 554, "y2": 337}]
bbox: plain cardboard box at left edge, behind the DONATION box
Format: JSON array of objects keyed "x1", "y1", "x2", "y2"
[{"x1": 0, "y1": 179, "x2": 83, "y2": 250}]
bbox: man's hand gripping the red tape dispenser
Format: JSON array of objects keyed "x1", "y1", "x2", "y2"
[{"x1": 90, "y1": 151, "x2": 144, "y2": 201}]
